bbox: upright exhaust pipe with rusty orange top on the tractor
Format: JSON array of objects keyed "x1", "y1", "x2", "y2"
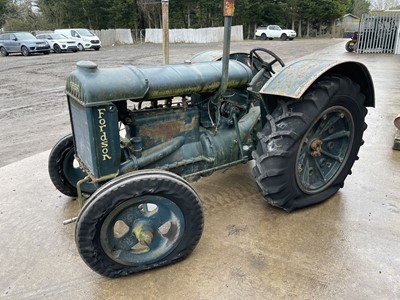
[{"x1": 211, "y1": 0, "x2": 235, "y2": 105}]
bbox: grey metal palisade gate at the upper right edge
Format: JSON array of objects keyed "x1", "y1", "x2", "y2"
[{"x1": 357, "y1": 14, "x2": 400, "y2": 53}]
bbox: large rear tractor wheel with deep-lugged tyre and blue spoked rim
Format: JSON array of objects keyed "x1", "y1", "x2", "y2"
[{"x1": 253, "y1": 75, "x2": 367, "y2": 211}]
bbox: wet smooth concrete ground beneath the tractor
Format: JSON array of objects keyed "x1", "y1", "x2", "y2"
[{"x1": 0, "y1": 40, "x2": 400, "y2": 299}]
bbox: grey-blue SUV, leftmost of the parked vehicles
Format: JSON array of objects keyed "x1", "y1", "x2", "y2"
[{"x1": 0, "y1": 32, "x2": 50, "y2": 56}]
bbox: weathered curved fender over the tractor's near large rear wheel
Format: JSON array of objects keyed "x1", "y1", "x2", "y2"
[{"x1": 260, "y1": 59, "x2": 375, "y2": 107}]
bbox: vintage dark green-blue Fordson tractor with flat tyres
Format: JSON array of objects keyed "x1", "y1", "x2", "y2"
[{"x1": 49, "y1": 0, "x2": 375, "y2": 277}]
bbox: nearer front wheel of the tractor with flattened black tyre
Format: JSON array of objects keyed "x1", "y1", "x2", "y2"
[{"x1": 75, "y1": 170, "x2": 204, "y2": 277}]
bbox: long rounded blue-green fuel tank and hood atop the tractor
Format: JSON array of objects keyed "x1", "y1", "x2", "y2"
[{"x1": 67, "y1": 61, "x2": 253, "y2": 106}]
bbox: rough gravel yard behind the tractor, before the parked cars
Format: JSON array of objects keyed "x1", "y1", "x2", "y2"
[{"x1": 0, "y1": 39, "x2": 343, "y2": 167}]
